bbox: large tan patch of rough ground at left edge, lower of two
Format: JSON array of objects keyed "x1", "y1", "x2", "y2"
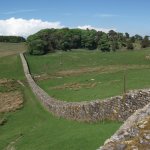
[{"x1": 0, "y1": 91, "x2": 23, "y2": 113}]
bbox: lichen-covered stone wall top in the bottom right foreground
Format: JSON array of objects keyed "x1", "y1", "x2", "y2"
[{"x1": 99, "y1": 104, "x2": 150, "y2": 150}]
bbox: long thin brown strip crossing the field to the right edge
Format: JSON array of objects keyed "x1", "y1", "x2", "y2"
[{"x1": 34, "y1": 65, "x2": 150, "y2": 81}]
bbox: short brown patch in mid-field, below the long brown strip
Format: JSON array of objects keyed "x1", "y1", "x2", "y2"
[{"x1": 50, "y1": 82, "x2": 97, "y2": 90}]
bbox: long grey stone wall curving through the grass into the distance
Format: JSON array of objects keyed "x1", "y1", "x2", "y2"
[{"x1": 20, "y1": 54, "x2": 150, "y2": 122}]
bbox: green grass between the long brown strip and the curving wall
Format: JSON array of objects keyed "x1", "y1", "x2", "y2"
[{"x1": 39, "y1": 69, "x2": 150, "y2": 101}]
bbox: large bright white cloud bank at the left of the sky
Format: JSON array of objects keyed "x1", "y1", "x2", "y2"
[{"x1": 0, "y1": 18, "x2": 64, "y2": 37}]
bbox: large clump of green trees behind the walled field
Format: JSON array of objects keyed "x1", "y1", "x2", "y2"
[{"x1": 27, "y1": 28, "x2": 150, "y2": 55}]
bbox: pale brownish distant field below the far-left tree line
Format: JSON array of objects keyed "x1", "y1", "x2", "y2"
[{"x1": 0, "y1": 42, "x2": 26, "y2": 57}]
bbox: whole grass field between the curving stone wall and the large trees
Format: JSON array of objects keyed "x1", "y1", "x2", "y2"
[{"x1": 26, "y1": 49, "x2": 150, "y2": 101}]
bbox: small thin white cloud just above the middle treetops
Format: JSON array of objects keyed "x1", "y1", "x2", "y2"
[{"x1": 78, "y1": 25, "x2": 117, "y2": 33}]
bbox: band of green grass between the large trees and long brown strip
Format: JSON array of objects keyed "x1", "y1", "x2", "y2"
[{"x1": 26, "y1": 49, "x2": 150, "y2": 74}]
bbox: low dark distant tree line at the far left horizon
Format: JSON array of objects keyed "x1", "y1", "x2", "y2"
[{"x1": 0, "y1": 36, "x2": 26, "y2": 43}]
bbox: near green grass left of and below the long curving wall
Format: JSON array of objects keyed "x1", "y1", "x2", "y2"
[{"x1": 0, "y1": 44, "x2": 121, "y2": 150}]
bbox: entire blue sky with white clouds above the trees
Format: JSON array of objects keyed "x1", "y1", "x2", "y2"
[{"x1": 0, "y1": 0, "x2": 150, "y2": 37}]
